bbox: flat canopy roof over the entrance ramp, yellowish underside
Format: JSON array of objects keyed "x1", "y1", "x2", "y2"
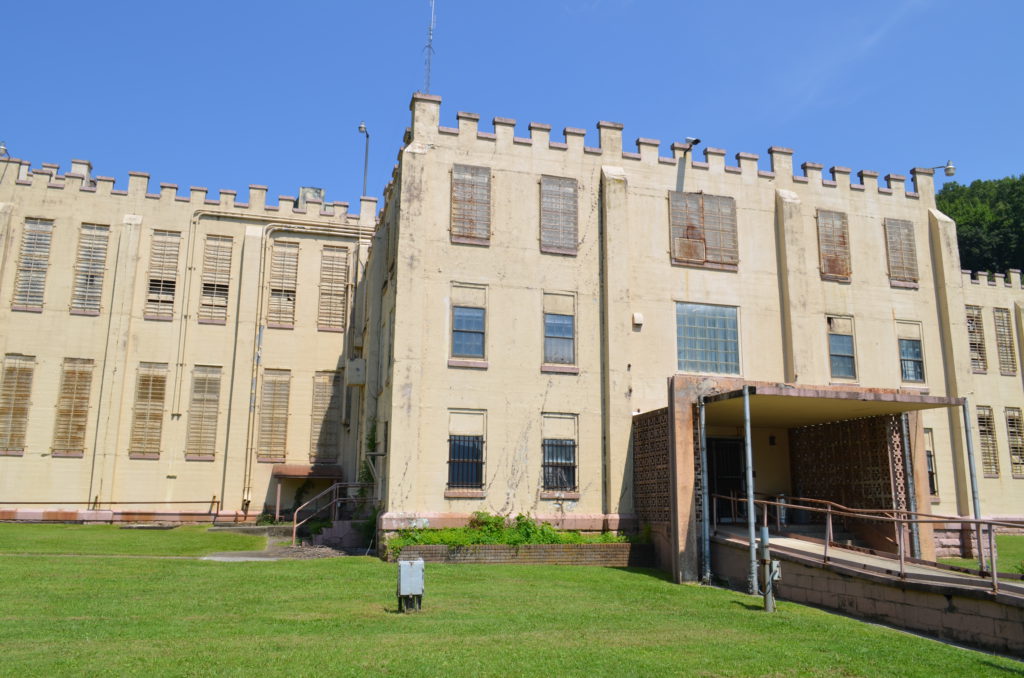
[{"x1": 705, "y1": 384, "x2": 962, "y2": 428}]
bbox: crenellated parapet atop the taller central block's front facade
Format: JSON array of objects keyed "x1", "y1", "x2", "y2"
[{"x1": 406, "y1": 93, "x2": 935, "y2": 200}]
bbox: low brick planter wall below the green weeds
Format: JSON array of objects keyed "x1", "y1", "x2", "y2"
[{"x1": 388, "y1": 544, "x2": 654, "y2": 567}]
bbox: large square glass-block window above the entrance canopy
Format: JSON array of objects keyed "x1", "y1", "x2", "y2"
[{"x1": 676, "y1": 303, "x2": 739, "y2": 374}]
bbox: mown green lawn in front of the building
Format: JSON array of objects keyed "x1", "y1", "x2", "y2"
[{"x1": 0, "y1": 525, "x2": 1024, "y2": 678}]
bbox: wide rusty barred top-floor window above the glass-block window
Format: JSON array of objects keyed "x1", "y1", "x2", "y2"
[{"x1": 669, "y1": 190, "x2": 739, "y2": 269}]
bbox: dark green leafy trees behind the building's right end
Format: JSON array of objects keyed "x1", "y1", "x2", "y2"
[{"x1": 935, "y1": 174, "x2": 1024, "y2": 272}]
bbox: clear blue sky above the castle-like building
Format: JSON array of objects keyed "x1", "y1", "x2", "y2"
[{"x1": 0, "y1": 0, "x2": 1024, "y2": 211}]
